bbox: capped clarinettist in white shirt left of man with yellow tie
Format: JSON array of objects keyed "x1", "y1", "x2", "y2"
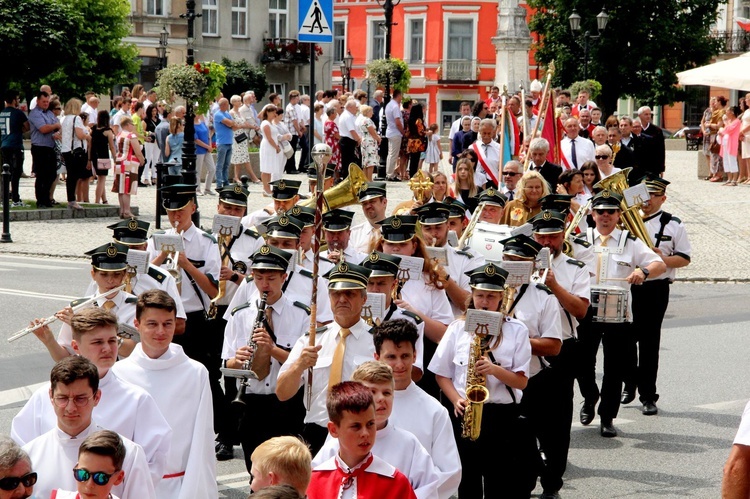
[{"x1": 221, "y1": 245, "x2": 310, "y2": 472}]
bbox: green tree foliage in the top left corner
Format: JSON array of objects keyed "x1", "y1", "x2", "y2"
[{"x1": 0, "y1": 0, "x2": 139, "y2": 100}]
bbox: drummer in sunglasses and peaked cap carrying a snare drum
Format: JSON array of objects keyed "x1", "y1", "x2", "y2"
[{"x1": 578, "y1": 189, "x2": 667, "y2": 438}]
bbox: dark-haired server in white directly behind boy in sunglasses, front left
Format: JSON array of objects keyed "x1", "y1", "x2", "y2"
[{"x1": 23, "y1": 356, "x2": 156, "y2": 499}]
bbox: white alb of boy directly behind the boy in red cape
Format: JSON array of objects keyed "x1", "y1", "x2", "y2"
[{"x1": 312, "y1": 421, "x2": 439, "y2": 499}]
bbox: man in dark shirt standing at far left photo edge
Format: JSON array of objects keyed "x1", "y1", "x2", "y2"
[{"x1": 0, "y1": 90, "x2": 29, "y2": 208}]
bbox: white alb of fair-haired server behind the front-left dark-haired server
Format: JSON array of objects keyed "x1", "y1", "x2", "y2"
[{"x1": 10, "y1": 370, "x2": 172, "y2": 484}]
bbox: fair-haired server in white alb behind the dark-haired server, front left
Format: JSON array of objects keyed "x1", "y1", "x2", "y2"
[{"x1": 10, "y1": 308, "x2": 172, "y2": 484}]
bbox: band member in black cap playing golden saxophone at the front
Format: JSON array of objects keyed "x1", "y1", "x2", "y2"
[{"x1": 428, "y1": 263, "x2": 531, "y2": 498}]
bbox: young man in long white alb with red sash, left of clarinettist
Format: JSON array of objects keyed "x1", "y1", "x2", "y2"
[{"x1": 113, "y1": 290, "x2": 219, "y2": 499}]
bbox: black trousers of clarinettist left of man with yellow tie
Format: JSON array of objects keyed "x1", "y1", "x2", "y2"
[{"x1": 240, "y1": 389, "x2": 304, "y2": 473}]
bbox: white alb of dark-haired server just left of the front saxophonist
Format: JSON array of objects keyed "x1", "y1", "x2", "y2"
[{"x1": 394, "y1": 382, "x2": 461, "y2": 499}]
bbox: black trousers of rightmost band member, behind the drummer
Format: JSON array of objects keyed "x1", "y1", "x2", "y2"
[{"x1": 625, "y1": 279, "x2": 670, "y2": 403}]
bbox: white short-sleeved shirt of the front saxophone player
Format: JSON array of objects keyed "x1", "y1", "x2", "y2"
[{"x1": 427, "y1": 318, "x2": 531, "y2": 404}]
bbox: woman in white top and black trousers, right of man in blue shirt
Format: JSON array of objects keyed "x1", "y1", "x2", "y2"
[{"x1": 60, "y1": 97, "x2": 91, "y2": 210}]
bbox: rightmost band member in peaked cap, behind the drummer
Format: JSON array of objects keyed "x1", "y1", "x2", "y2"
[{"x1": 621, "y1": 176, "x2": 691, "y2": 416}]
